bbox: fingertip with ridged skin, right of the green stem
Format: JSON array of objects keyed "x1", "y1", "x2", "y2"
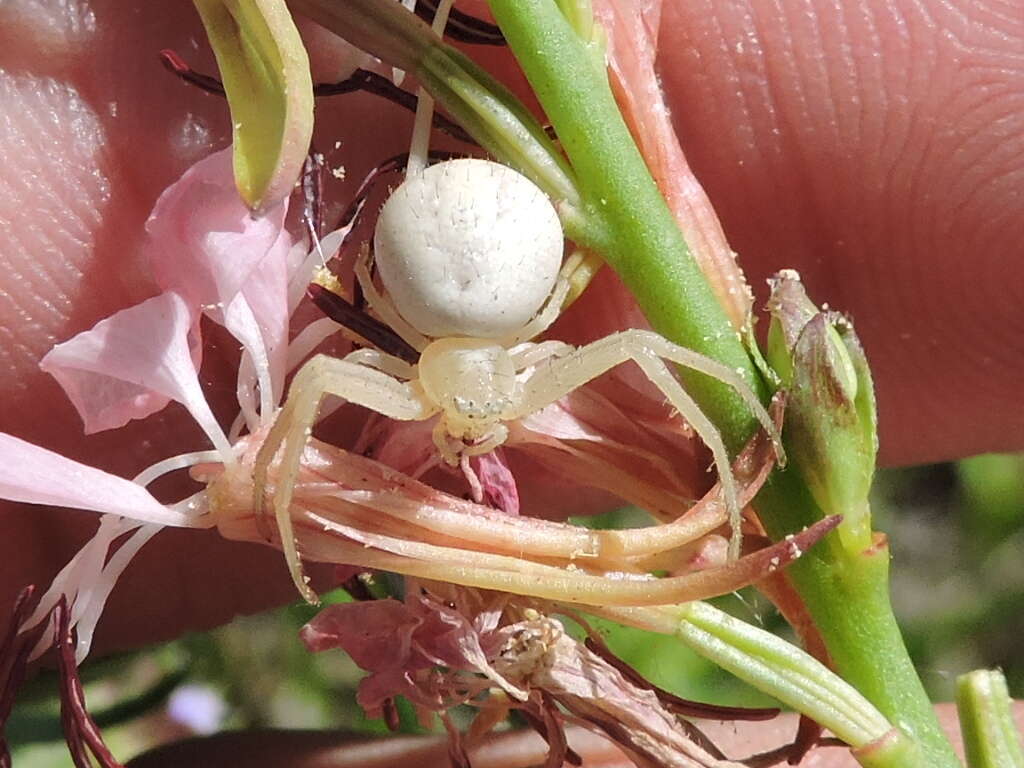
[{"x1": 658, "y1": 0, "x2": 1024, "y2": 464}]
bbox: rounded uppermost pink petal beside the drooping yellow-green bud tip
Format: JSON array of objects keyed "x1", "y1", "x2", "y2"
[{"x1": 145, "y1": 147, "x2": 288, "y2": 311}]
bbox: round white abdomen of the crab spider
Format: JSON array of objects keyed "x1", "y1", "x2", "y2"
[{"x1": 374, "y1": 159, "x2": 564, "y2": 338}]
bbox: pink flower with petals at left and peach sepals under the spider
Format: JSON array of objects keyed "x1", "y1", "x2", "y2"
[{"x1": 0, "y1": 144, "x2": 815, "y2": 671}]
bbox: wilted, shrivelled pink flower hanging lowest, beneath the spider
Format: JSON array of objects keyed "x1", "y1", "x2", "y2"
[{"x1": 301, "y1": 581, "x2": 776, "y2": 768}]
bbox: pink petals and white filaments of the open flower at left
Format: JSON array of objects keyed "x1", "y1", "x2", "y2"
[{"x1": 0, "y1": 151, "x2": 305, "y2": 660}]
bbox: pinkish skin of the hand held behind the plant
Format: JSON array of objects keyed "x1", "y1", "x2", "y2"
[{"x1": 0, "y1": 0, "x2": 1024, "y2": 765}]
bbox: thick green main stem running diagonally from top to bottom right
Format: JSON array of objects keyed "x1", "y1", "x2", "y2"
[{"x1": 490, "y1": 0, "x2": 959, "y2": 768}]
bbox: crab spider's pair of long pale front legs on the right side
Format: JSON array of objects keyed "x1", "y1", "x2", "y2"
[{"x1": 503, "y1": 330, "x2": 781, "y2": 557}]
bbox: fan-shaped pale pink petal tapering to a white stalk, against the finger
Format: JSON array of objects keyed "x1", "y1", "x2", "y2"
[{"x1": 39, "y1": 293, "x2": 230, "y2": 455}]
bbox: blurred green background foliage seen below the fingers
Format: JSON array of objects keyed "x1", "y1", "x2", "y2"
[{"x1": 7, "y1": 455, "x2": 1024, "y2": 768}]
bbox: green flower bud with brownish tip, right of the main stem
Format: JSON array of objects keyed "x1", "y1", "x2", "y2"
[{"x1": 768, "y1": 271, "x2": 878, "y2": 547}]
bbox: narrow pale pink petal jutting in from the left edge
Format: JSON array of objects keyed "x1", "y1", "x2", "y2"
[{"x1": 0, "y1": 432, "x2": 196, "y2": 527}]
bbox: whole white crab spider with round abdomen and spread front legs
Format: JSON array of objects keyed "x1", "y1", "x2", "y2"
[{"x1": 254, "y1": 159, "x2": 775, "y2": 601}]
